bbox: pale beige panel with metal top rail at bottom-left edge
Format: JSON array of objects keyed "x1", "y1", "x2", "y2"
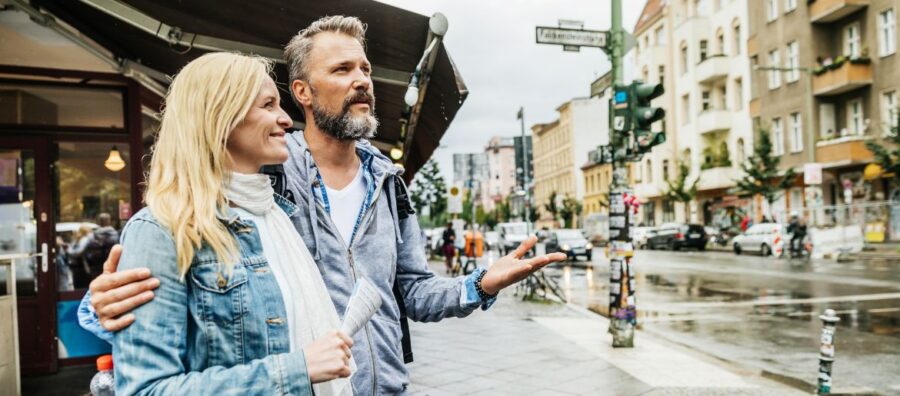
[{"x1": 0, "y1": 255, "x2": 22, "y2": 395}]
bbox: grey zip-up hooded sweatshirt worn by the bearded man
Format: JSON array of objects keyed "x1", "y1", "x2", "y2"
[{"x1": 284, "y1": 132, "x2": 493, "y2": 395}]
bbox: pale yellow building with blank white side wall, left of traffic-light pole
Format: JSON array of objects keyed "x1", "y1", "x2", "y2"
[{"x1": 531, "y1": 97, "x2": 609, "y2": 227}]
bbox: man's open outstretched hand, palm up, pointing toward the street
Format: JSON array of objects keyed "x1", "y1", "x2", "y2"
[{"x1": 481, "y1": 235, "x2": 566, "y2": 295}]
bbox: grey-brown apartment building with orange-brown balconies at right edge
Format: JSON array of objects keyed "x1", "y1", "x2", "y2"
[{"x1": 747, "y1": 0, "x2": 900, "y2": 218}]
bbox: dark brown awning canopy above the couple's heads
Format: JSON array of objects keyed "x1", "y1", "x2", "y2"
[{"x1": 31, "y1": 0, "x2": 468, "y2": 178}]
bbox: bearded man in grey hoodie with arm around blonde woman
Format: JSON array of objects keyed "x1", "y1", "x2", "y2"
[{"x1": 82, "y1": 16, "x2": 565, "y2": 395}]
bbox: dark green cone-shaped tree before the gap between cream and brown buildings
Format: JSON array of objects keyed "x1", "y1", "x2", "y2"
[{"x1": 737, "y1": 129, "x2": 797, "y2": 213}]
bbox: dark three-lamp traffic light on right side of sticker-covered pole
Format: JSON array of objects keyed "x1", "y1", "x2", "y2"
[{"x1": 628, "y1": 80, "x2": 666, "y2": 154}]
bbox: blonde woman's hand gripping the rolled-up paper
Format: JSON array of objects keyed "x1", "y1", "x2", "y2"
[{"x1": 304, "y1": 330, "x2": 353, "y2": 384}]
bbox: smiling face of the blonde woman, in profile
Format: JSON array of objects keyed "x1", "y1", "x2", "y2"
[{"x1": 227, "y1": 77, "x2": 293, "y2": 173}]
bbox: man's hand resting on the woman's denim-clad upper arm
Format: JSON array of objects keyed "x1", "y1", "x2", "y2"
[{"x1": 91, "y1": 245, "x2": 159, "y2": 332}]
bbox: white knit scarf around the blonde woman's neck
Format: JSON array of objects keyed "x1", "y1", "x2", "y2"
[{"x1": 225, "y1": 172, "x2": 356, "y2": 396}]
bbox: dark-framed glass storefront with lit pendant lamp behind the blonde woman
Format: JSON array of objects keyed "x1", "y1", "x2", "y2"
[{"x1": 0, "y1": 66, "x2": 159, "y2": 374}]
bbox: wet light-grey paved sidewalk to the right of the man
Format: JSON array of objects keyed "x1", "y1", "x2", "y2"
[{"x1": 409, "y1": 262, "x2": 809, "y2": 396}]
